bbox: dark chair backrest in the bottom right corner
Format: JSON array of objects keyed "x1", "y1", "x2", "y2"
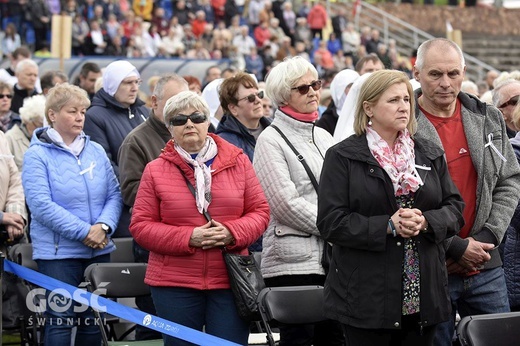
[{"x1": 457, "y1": 312, "x2": 520, "y2": 346}]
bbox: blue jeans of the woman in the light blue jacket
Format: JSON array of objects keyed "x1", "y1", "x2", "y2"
[{"x1": 36, "y1": 254, "x2": 110, "y2": 346}]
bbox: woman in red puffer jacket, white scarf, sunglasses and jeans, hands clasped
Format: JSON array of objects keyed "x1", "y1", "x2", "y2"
[{"x1": 130, "y1": 91, "x2": 269, "y2": 345}]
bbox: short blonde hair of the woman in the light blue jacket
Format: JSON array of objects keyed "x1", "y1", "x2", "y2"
[{"x1": 45, "y1": 83, "x2": 90, "y2": 127}]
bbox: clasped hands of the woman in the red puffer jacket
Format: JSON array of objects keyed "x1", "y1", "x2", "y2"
[{"x1": 190, "y1": 220, "x2": 235, "y2": 250}]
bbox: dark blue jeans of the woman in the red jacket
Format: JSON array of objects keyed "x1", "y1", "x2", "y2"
[{"x1": 150, "y1": 287, "x2": 249, "y2": 346}]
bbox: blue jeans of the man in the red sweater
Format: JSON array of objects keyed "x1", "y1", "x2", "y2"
[{"x1": 433, "y1": 267, "x2": 509, "y2": 346}]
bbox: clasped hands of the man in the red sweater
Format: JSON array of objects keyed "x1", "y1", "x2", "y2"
[{"x1": 446, "y1": 237, "x2": 495, "y2": 274}]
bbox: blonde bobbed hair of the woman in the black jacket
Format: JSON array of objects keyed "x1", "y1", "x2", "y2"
[{"x1": 354, "y1": 70, "x2": 417, "y2": 136}]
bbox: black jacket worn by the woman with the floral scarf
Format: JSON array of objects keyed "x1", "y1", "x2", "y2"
[{"x1": 317, "y1": 136, "x2": 464, "y2": 329}]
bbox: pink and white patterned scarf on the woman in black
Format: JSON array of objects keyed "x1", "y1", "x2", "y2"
[{"x1": 366, "y1": 126, "x2": 424, "y2": 196}]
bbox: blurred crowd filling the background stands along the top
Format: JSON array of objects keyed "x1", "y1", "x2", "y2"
[{"x1": 0, "y1": 0, "x2": 412, "y2": 80}]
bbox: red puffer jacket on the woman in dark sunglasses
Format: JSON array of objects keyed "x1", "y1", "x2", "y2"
[{"x1": 130, "y1": 134, "x2": 269, "y2": 290}]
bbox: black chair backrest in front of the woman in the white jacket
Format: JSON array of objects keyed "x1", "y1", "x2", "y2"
[{"x1": 257, "y1": 286, "x2": 326, "y2": 324}]
